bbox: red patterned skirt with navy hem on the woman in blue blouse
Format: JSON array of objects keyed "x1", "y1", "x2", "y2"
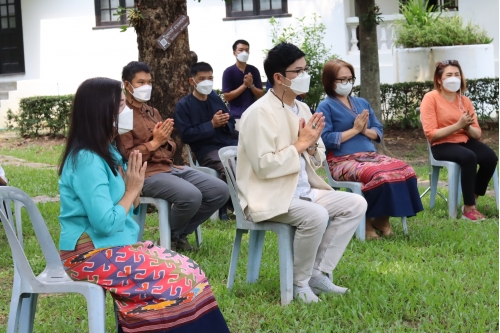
[{"x1": 328, "y1": 152, "x2": 424, "y2": 217}]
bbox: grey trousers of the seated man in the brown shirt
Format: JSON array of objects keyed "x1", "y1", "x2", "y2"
[{"x1": 142, "y1": 166, "x2": 229, "y2": 239}]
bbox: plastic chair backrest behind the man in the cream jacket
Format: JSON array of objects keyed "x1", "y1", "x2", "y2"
[{"x1": 219, "y1": 146, "x2": 252, "y2": 228}]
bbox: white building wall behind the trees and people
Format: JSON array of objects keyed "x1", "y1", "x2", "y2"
[{"x1": 0, "y1": 0, "x2": 499, "y2": 128}]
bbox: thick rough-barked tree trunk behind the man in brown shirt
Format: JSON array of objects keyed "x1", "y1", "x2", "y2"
[{"x1": 135, "y1": 0, "x2": 191, "y2": 165}]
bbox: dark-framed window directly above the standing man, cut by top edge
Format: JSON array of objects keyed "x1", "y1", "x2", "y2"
[{"x1": 224, "y1": 0, "x2": 292, "y2": 20}]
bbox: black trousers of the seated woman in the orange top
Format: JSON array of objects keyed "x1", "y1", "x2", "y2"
[{"x1": 431, "y1": 139, "x2": 498, "y2": 206}]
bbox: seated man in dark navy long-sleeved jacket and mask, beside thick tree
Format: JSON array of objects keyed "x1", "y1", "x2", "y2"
[{"x1": 174, "y1": 62, "x2": 238, "y2": 220}]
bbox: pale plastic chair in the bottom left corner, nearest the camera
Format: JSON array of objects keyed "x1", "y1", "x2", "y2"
[{"x1": 0, "y1": 186, "x2": 106, "y2": 333}]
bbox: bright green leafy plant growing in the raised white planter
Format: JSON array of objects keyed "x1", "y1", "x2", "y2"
[{"x1": 394, "y1": 0, "x2": 493, "y2": 48}]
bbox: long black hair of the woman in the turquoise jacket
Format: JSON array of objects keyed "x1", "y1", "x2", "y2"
[{"x1": 58, "y1": 77, "x2": 121, "y2": 176}]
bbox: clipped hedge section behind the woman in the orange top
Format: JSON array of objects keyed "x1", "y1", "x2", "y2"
[{"x1": 353, "y1": 78, "x2": 499, "y2": 128}]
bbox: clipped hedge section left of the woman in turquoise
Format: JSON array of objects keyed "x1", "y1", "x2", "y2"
[{"x1": 6, "y1": 95, "x2": 73, "y2": 136}]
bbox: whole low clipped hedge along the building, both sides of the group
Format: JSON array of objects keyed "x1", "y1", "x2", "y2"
[{"x1": 6, "y1": 78, "x2": 499, "y2": 136}]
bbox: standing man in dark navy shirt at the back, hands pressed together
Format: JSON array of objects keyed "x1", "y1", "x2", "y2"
[{"x1": 222, "y1": 39, "x2": 264, "y2": 129}]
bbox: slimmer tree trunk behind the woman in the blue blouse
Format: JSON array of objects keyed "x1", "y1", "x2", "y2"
[{"x1": 356, "y1": 0, "x2": 392, "y2": 156}]
